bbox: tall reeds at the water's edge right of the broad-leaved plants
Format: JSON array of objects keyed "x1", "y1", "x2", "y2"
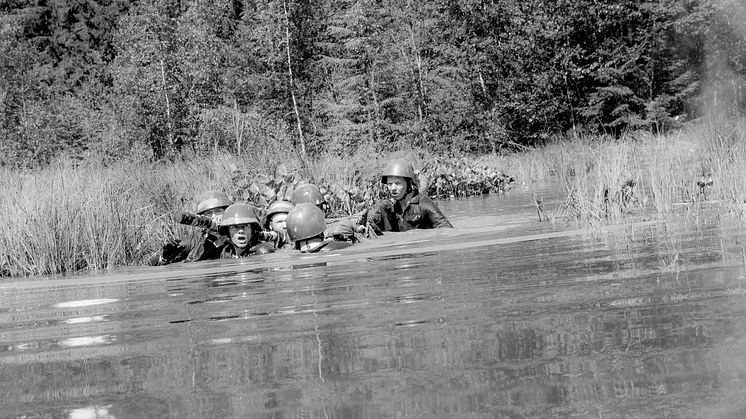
[{"x1": 505, "y1": 119, "x2": 746, "y2": 223}]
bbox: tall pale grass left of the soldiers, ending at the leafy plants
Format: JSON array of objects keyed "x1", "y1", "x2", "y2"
[{"x1": 0, "y1": 156, "x2": 251, "y2": 276}]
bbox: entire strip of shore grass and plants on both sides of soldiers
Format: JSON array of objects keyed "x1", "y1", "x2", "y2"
[{"x1": 0, "y1": 116, "x2": 746, "y2": 277}]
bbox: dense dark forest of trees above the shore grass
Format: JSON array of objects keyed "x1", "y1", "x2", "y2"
[{"x1": 0, "y1": 0, "x2": 746, "y2": 166}]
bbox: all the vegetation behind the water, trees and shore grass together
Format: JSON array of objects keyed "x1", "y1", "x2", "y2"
[{"x1": 0, "y1": 0, "x2": 746, "y2": 276}]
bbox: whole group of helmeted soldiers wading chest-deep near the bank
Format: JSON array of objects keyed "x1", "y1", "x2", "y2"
[{"x1": 150, "y1": 159, "x2": 453, "y2": 265}]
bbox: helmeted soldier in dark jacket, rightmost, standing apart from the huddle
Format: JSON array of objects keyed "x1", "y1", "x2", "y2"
[{"x1": 368, "y1": 159, "x2": 453, "y2": 234}]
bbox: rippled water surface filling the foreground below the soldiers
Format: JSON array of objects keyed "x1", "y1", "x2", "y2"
[{"x1": 0, "y1": 188, "x2": 746, "y2": 418}]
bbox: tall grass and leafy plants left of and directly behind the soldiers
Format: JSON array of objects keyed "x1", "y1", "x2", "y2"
[{"x1": 0, "y1": 150, "x2": 508, "y2": 276}]
